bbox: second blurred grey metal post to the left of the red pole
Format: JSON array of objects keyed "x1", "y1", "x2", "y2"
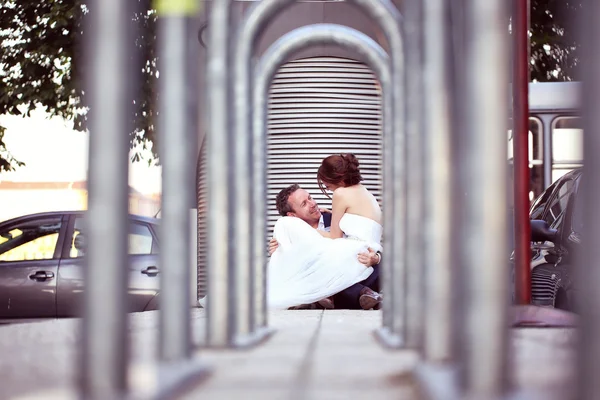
[{"x1": 423, "y1": 0, "x2": 453, "y2": 363}]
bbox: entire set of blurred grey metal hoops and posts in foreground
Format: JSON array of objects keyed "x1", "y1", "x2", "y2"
[{"x1": 79, "y1": 0, "x2": 600, "y2": 399}]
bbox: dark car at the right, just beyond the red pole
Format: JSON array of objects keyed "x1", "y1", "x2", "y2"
[{"x1": 529, "y1": 168, "x2": 583, "y2": 311}]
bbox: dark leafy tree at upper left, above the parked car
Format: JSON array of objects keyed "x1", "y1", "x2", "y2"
[{"x1": 0, "y1": 0, "x2": 157, "y2": 171}]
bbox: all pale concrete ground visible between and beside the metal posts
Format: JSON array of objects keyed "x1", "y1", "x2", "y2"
[{"x1": 0, "y1": 310, "x2": 576, "y2": 400}]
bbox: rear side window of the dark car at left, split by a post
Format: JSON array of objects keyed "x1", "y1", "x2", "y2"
[{"x1": 69, "y1": 217, "x2": 154, "y2": 258}]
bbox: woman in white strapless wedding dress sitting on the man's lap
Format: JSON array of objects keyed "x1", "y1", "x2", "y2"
[{"x1": 267, "y1": 154, "x2": 382, "y2": 309}]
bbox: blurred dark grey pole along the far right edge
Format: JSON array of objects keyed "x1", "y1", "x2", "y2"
[{"x1": 576, "y1": 0, "x2": 600, "y2": 400}]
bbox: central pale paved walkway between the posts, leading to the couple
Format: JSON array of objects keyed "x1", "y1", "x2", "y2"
[{"x1": 184, "y1": 310, "x2": 418, "y2": 400}]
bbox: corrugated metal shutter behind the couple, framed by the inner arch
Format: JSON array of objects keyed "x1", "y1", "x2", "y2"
[{"x1": 267, "y1": 57, "x2": 382, "y2": 234}]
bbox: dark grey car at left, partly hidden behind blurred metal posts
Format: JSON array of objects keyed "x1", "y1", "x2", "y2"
[{"x1": 0, "y1": 211, "x2": 159, "y2": 320}]
